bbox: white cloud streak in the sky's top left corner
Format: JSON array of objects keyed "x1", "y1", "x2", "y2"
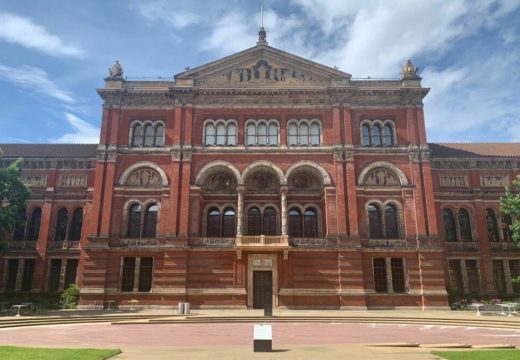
[{"x1": 0, "y1": 12, "x2": 85, "y2": 57}]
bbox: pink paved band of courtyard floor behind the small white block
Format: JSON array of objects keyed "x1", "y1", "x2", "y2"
[{"x1": 0, "y1": 323, "x2": 520, "y2": 348}]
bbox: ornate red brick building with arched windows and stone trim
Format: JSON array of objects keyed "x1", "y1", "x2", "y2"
[{"x1": 0, "y1": 43, "x2": 520, "y2": 308}]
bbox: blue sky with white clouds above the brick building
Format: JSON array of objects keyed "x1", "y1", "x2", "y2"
[{"x1": 0, "y1": 0, "x2": 520, "y2": 143}]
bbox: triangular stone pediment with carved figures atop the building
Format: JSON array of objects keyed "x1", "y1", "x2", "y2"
[{"x1": 175, "y1": 45, "x2": 351, "y2": 88}]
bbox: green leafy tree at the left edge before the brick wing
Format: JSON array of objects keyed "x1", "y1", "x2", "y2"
[{"x1": 0, "y1": 149, "x2": 31, "y2": 251}]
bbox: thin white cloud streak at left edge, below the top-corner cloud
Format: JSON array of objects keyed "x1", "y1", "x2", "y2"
[{"x1": 0, "y1": 63, "x2": 76, "y2": 105}]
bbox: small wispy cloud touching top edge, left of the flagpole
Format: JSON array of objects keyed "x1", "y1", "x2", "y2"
[{"x1": 136, "y1": 0, "x2": 201, "y2": 30}]
